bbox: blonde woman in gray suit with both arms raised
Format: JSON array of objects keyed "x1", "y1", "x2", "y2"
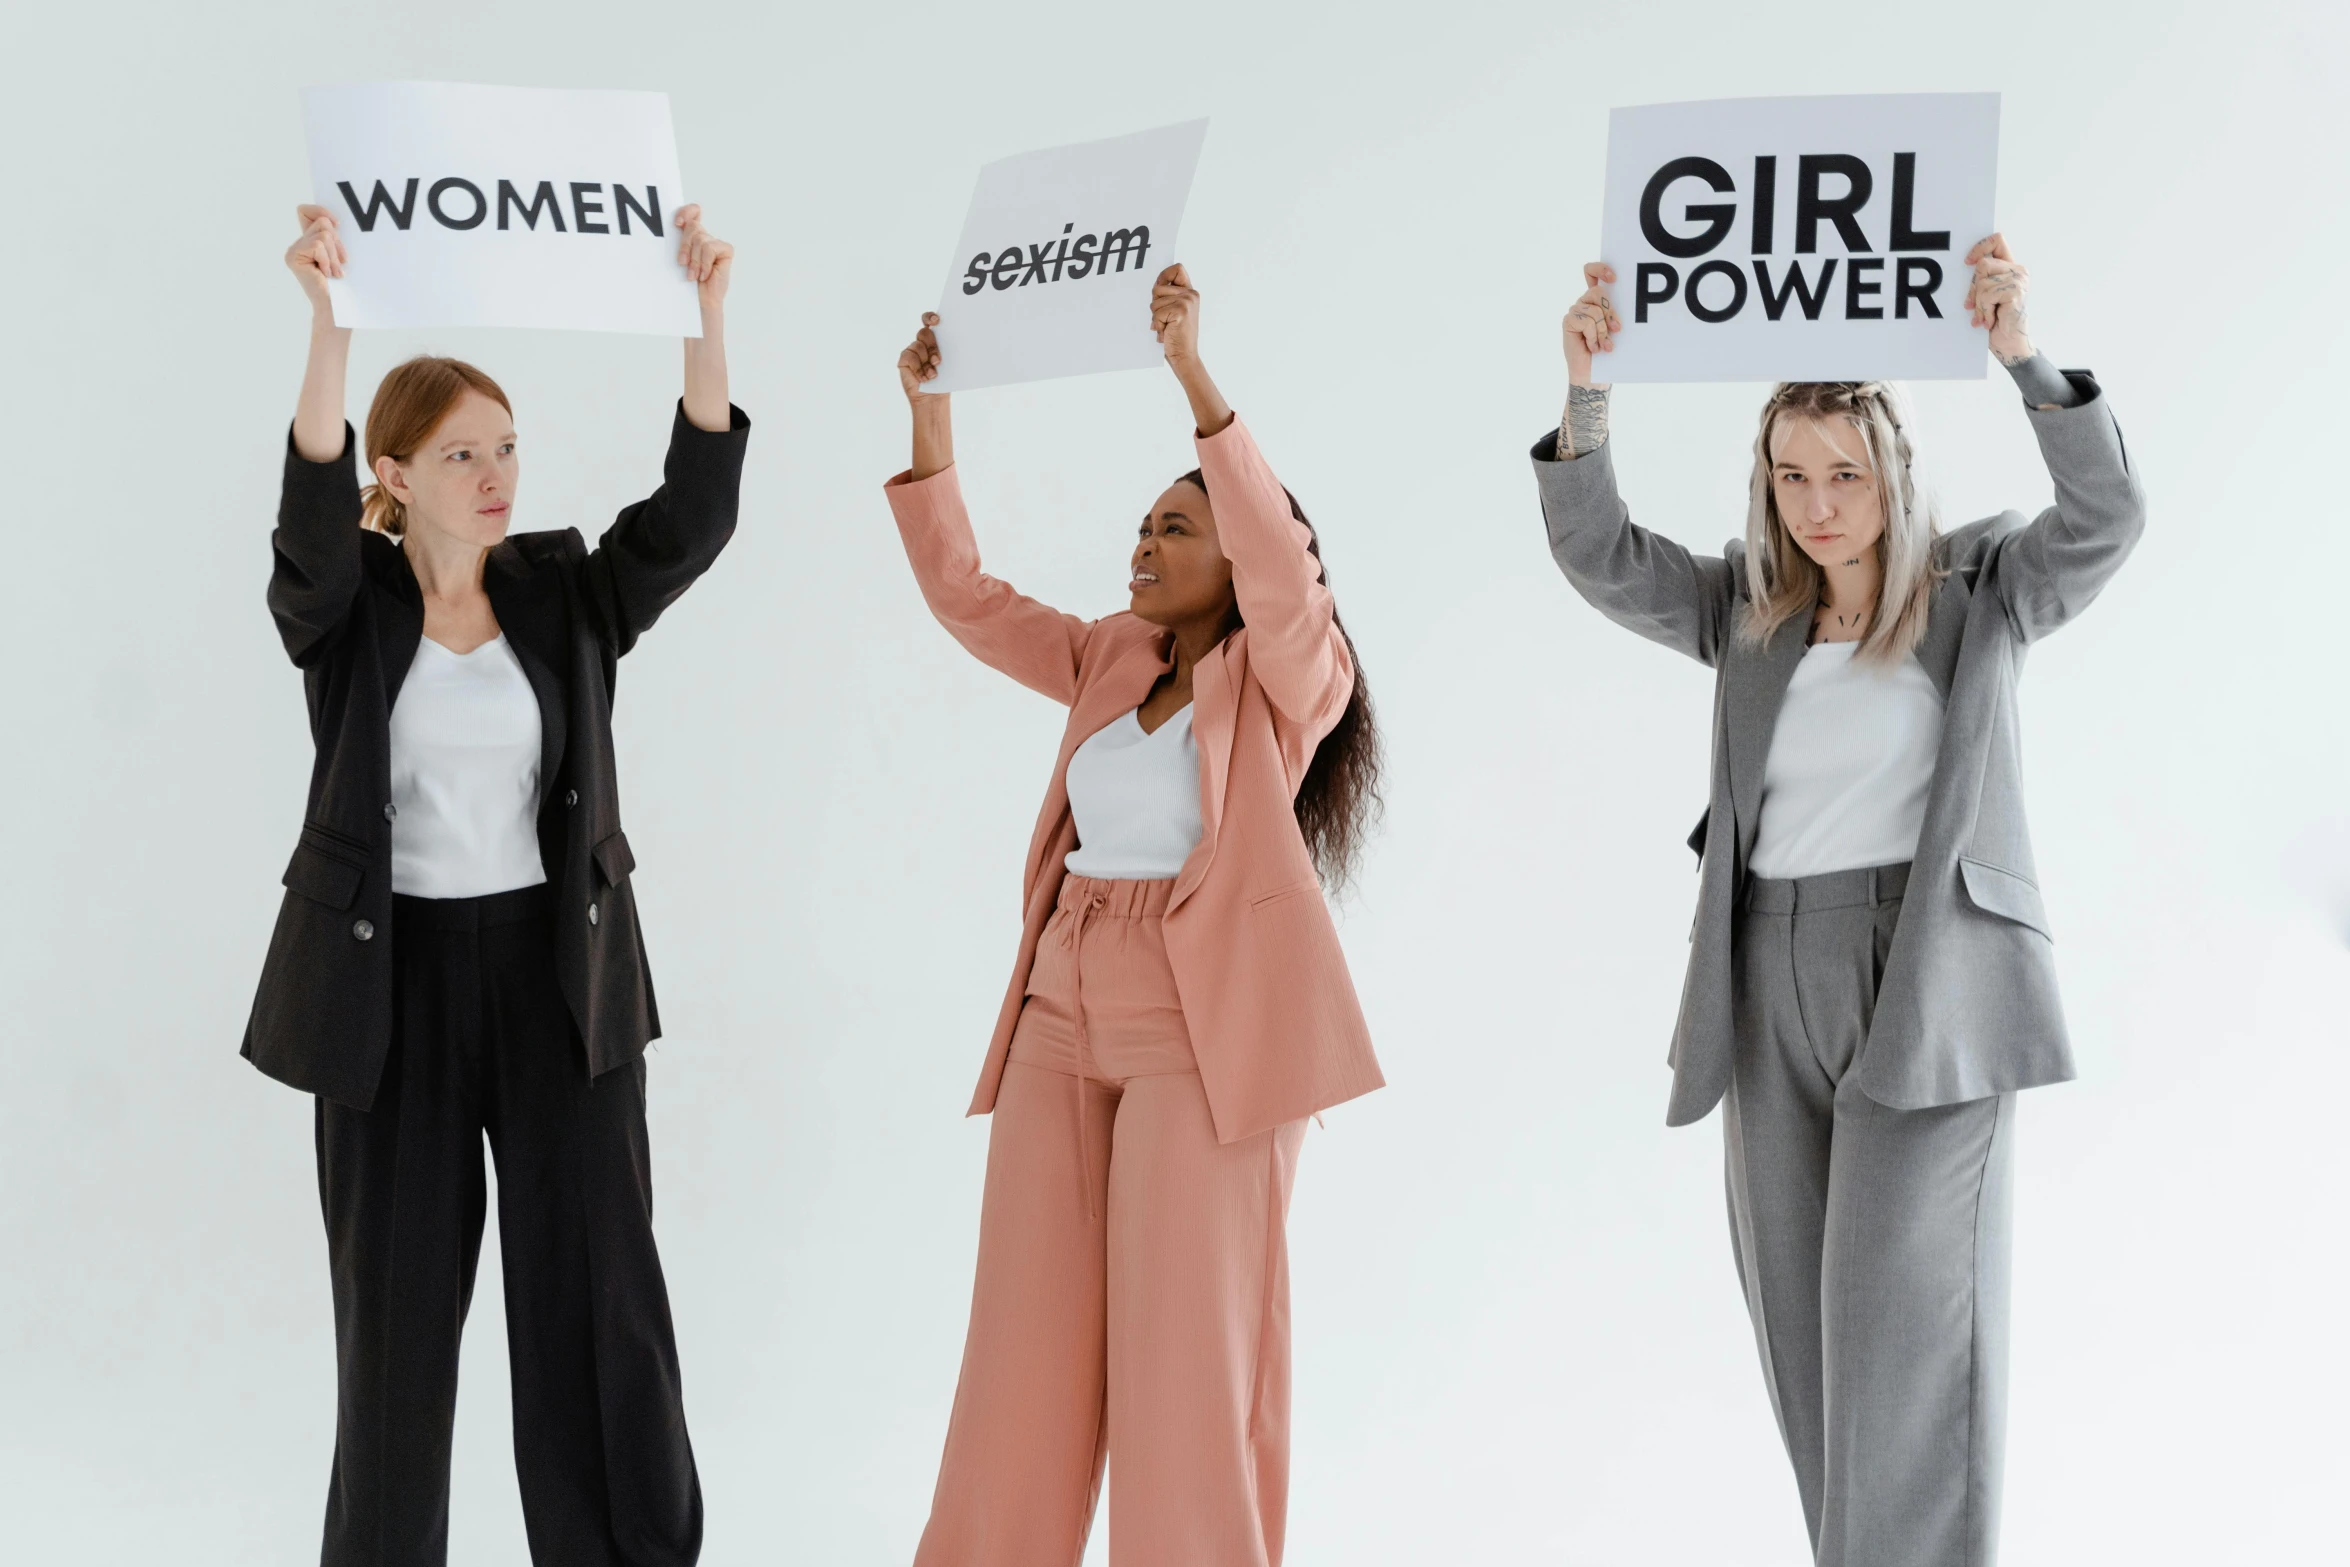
[{"x1": 1535, "y1": 235, "x2": 2143, "y2": 1567}]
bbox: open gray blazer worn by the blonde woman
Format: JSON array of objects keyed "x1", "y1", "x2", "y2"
[{"x1": 1535, "y1": 371, "x2": 2146, "y2": 1125}]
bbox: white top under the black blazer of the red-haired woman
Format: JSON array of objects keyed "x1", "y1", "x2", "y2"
[{"x1": 392, "y1": 637, "x2": 548, "y2": 897}]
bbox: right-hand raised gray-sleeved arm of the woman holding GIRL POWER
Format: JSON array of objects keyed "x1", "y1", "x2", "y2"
[{"x1": 1967, "y1": 235, "x2": 2146, "y2": 641}]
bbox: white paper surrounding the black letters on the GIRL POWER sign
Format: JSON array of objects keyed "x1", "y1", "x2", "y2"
[{"x1": 1600, "y1": 92, "x2": 2000, "y2": 383}]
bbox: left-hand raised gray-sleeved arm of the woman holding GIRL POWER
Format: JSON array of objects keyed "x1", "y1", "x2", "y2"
[{"x1": 1535, "y1": 263, "x2": 1737, "y2": 665}]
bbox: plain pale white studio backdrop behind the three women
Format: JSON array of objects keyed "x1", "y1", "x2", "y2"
[{"x1": 0, "y1": 0, "x2": 2350, "y2": 1567}]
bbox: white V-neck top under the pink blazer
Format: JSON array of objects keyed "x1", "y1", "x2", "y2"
[{"x1": 1067, "y1": 702, "x2": 1201, "y2": 881}]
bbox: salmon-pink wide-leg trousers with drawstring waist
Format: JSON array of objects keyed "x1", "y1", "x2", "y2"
[{"x1": 914, "y1": 876, "x2": 1304, "y2": 1567}]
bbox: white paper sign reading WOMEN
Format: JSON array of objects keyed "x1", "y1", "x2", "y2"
[{"x1": 303, "y1": 82, "x2": 703, "y2": 338}]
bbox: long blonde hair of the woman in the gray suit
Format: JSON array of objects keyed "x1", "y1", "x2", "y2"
[{"x1": 1739, "y1": 381, "x2": 1943, "y2": 663}]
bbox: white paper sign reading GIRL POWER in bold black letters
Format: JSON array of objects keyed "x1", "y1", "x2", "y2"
[{"x1": 1593, "y1": 92, "x2": 2000, "y2": 381}]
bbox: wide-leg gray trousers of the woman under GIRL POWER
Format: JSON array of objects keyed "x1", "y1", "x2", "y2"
[{"x1": 1723, "y1": 865, "x2": 2016, "y2": 1567}]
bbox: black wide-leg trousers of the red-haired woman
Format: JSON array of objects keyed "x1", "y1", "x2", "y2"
[{"x1": 317, "y1": 888, "x2": 703, "y2": 1567}]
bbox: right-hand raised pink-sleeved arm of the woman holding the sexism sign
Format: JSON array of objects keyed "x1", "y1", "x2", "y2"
[{"x1": 1152, "y1": 263, "x2": 1354, "y2": 740}]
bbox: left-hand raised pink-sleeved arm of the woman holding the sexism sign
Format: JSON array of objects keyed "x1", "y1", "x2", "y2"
[{"x1": 881, "y1": 312, "x2": 1095, "y2": 705}]
